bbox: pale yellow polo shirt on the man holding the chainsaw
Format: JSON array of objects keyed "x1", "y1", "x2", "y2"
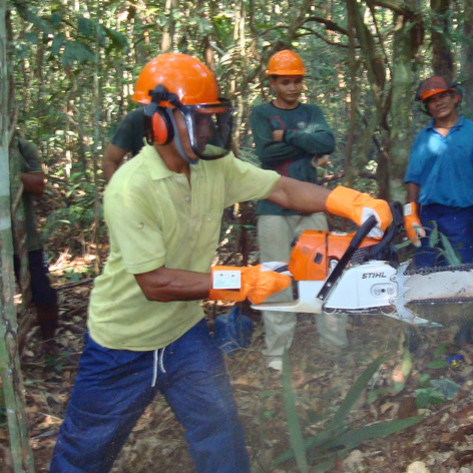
[{"x1": 88, "y1": 146, "x2": 280, "y2": 351}]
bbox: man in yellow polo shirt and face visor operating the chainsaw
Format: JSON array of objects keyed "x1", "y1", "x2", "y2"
[{"x1": 51, "y1": 53, "x2": 392, "y2": 473}]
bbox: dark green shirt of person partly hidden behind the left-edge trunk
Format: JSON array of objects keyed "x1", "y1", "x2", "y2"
[{"x1": 12, "y1": 138, "x2": 43, "y2": 254}]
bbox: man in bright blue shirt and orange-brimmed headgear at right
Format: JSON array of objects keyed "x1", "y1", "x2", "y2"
[{"x1": 404, "y1": 76, "x2": 473, "y2": 339}]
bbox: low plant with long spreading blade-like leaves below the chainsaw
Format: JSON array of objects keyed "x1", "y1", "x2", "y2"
[{"x1": 273, "y1": 353, "x2": 422, "y2": 473}]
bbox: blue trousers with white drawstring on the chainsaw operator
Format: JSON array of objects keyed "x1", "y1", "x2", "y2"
[{"x1": 50, "y1": 321, "x2": 249, "y2": 473}]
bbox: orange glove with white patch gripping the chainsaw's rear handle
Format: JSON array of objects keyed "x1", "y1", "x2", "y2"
[{"x1": 209, "y1": 264, "x2": 291, "y2": 304}]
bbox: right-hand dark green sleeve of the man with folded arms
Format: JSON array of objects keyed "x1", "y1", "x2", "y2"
[{"x1": 284, "y1": 105, "x2": 335, "y2": 155}]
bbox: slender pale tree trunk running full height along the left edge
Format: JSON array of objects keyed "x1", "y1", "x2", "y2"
[{"x1": 0, "y1": 0, "x2": 34, "y2": 473}]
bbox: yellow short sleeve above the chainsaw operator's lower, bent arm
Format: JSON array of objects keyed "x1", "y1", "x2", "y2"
[{"x1": 104, "y1": 184, "x2": 166, "y2": 274}]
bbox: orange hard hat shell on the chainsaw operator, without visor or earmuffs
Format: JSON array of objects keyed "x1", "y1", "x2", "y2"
[{"x1": 132, "y1": 53, "x2": 220, "y2": 107}]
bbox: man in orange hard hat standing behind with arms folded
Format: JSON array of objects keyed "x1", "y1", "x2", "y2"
[{"x1": 250, "y1": 49, "x2": 348, "y2": 371}]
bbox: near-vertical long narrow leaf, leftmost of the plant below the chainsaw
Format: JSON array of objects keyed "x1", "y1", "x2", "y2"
[{"x1": 282, "y1": 350, "x2": 309, "y2": 473}]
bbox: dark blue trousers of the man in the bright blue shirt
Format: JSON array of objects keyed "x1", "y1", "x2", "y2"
[{"x1": 414, "y1": 204, "x2": 473, "y2": 267}]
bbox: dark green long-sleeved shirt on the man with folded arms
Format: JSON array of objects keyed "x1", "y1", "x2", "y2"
[{"x1": 250, "y1": 103, "x2": 335, "y2": 215}]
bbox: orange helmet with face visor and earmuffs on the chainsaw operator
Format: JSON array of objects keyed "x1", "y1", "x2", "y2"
[{"x1": 132, "y1": 53, "x2": 233, "y2": 164}]
